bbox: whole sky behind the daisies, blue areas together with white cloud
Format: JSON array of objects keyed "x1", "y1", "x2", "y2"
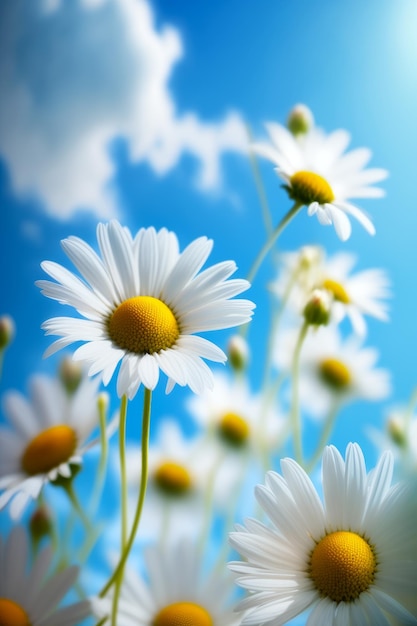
[{"x1": 0, "y1": 0, "x2": 417, "y2": 596}]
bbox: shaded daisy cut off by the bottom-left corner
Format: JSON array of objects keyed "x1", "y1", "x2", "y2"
[{"x1": 0, "y1": 526, "x2": 94, "y2": 626}]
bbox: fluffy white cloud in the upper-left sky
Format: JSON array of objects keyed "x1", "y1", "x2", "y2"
[{"x1": 0, "y1": 0, "x2": 246, "y2": 218}]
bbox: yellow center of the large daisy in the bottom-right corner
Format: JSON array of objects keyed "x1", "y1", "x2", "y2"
[{"x1": 309, "y1": 531, "x2": 377, "y2": 602}]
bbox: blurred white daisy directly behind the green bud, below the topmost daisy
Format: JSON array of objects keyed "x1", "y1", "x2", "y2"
[{"x1": 271, "y1": 246, "x2": 391, "y2": 337}]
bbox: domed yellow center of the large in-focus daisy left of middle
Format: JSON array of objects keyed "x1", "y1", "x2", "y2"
[{"x1": 107, "y1": 296, "x2": 180, "y2": 354}]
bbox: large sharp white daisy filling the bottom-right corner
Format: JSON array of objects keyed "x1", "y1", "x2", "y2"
[{"x1": 230, "y1": 444, "x2": 417, "y2": 626}]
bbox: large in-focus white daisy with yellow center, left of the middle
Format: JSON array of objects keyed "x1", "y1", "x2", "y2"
[{"x1": 37, "y1": 221, "x2": 254, "y2": 398}]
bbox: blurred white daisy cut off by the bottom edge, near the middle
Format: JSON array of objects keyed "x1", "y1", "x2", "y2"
[{"x1": 105, "y1": 540, "x2": 240, "y2": 626}]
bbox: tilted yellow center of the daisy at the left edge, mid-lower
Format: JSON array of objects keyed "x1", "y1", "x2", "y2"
[{"x1": 21, "y1": 424, "x2": 77, "y2": 476}]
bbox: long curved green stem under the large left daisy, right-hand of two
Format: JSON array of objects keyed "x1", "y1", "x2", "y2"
[{"x1": 99, "y1": 388, "x2": 152, "y2": 597}]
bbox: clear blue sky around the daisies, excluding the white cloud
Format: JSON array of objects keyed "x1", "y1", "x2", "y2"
[{"x1": 0, "y1": 0, "x2": 417, "y2": 620}]
